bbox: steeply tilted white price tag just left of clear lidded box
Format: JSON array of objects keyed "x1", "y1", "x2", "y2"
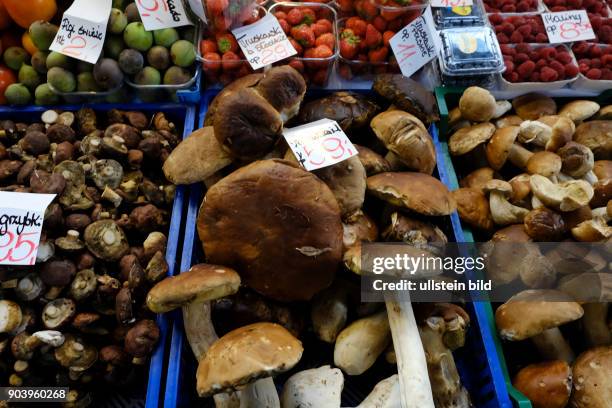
[{"x1": 389, "y1": 8, "x2": 438, "y2": 77}]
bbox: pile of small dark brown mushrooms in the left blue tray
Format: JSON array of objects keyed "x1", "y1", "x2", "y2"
[{"x1": 0, "y1": 108, "x2": 179, "y2": 406}]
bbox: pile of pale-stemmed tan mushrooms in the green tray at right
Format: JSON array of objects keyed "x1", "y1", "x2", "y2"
[{"x1": 448, "y1": 87, "x2": 612, "y2": 408}]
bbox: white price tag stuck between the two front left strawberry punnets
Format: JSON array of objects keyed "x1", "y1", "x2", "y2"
[{"x1": 232, "y1": 14, "x2": 297, "y2": 69}]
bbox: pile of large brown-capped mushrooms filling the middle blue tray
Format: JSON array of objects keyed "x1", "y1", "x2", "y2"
[{"x1": 157, "y1": 71, "x2": 471, "y2": 408}]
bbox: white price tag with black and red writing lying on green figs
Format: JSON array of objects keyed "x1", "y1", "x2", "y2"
[{"x1": 49, "y1": 0, "x2": 112, "y2": 64}]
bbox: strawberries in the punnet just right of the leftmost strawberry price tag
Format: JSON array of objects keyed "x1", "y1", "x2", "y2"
[{"x1": 274, "y1": 7, "x2": 336, "y2": 85}]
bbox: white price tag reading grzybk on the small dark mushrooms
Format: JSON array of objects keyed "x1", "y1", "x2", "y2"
[{"x1": 0, "y1": 192, "x2": 55, "y2": 265}]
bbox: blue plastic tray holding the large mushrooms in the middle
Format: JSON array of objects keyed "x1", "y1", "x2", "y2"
[{"x1": 164, "y1": 90, "x2": 511, "y2": 408}]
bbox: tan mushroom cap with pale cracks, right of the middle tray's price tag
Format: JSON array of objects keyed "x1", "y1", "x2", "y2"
[{"x1": 370, "y1": 110, "x2": 436, "y2": 174}]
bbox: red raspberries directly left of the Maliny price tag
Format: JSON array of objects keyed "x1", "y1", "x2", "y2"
[{"x1": 489, "y1": 14, "x2": 548, "y2": 44}]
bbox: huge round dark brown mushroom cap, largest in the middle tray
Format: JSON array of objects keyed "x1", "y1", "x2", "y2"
[{"x1": 198, "y1": 160, "x2": 342, "y2": 301}]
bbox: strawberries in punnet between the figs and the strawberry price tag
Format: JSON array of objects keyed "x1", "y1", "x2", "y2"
[{"x1": 200, "y1": 32, "x2": 253, "y2": 85}]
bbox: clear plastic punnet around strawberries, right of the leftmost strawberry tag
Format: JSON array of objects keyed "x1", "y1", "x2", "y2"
[{"x1": 268, "y1": 2, "x2": 339, "y2": 87}]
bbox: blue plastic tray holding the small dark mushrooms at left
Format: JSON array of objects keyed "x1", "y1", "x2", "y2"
[{"x1": 0, "y1": 103, "x2": 195, "y2": 408}]
